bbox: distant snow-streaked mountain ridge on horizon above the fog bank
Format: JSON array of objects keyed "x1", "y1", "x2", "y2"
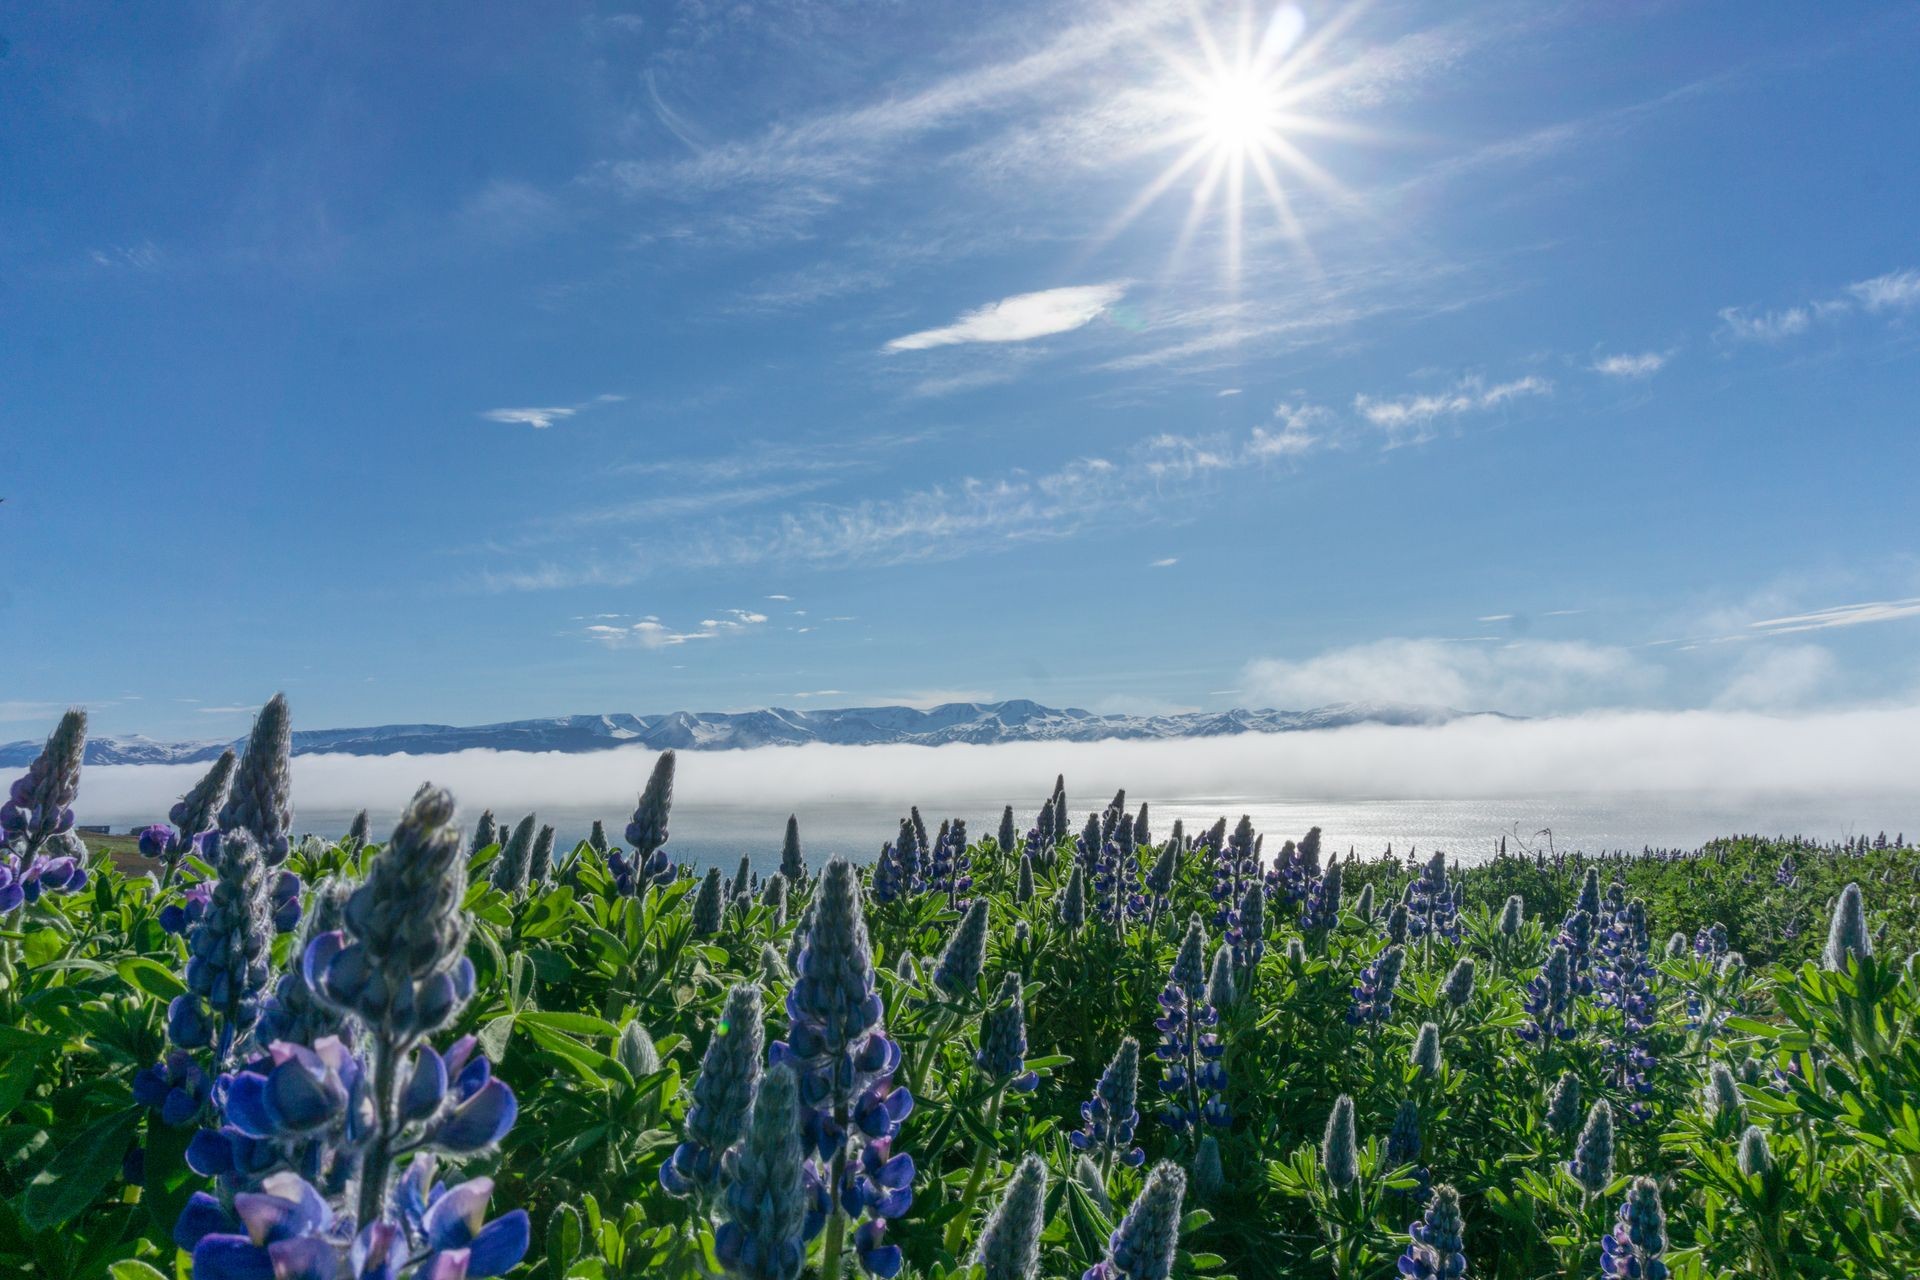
[{"x1": 0, "y1": 699, "x2": 1498, "y2": 768}]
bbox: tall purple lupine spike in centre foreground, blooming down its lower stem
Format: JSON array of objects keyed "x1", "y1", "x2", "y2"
[{"x1": 770, "y1": 858, "x2": 914, "y2": 1276}]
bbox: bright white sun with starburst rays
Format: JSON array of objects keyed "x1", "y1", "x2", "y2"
[{"x1": 1102, "y1": 4, "x2": 1361, "y2": 286}]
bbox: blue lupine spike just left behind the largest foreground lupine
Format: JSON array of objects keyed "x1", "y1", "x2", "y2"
[{"x1": 167, "y1": 831, "x2": 273, "y2": 1065}]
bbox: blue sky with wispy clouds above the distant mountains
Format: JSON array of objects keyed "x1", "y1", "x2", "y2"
[{"x1": 0, "y1": 0, "x2": 1920, "y2": 737}]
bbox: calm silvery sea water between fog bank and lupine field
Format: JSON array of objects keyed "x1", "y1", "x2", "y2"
[{"x1": 274, "y1": 793, "x2": 1920, "y2": 871}]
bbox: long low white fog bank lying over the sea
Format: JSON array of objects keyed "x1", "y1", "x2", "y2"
[{"x1": 81, "y1": 708, "x2": 1920, "y2": 825}]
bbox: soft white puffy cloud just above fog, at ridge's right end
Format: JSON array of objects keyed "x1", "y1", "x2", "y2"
[{"x1": 1240, "y1": 639, "x2": 1659, "y2": 714}]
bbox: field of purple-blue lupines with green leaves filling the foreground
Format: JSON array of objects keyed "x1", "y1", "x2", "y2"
[{"x1": 0, "y1": 699, "x2": 1920, "y2": 1280}]
